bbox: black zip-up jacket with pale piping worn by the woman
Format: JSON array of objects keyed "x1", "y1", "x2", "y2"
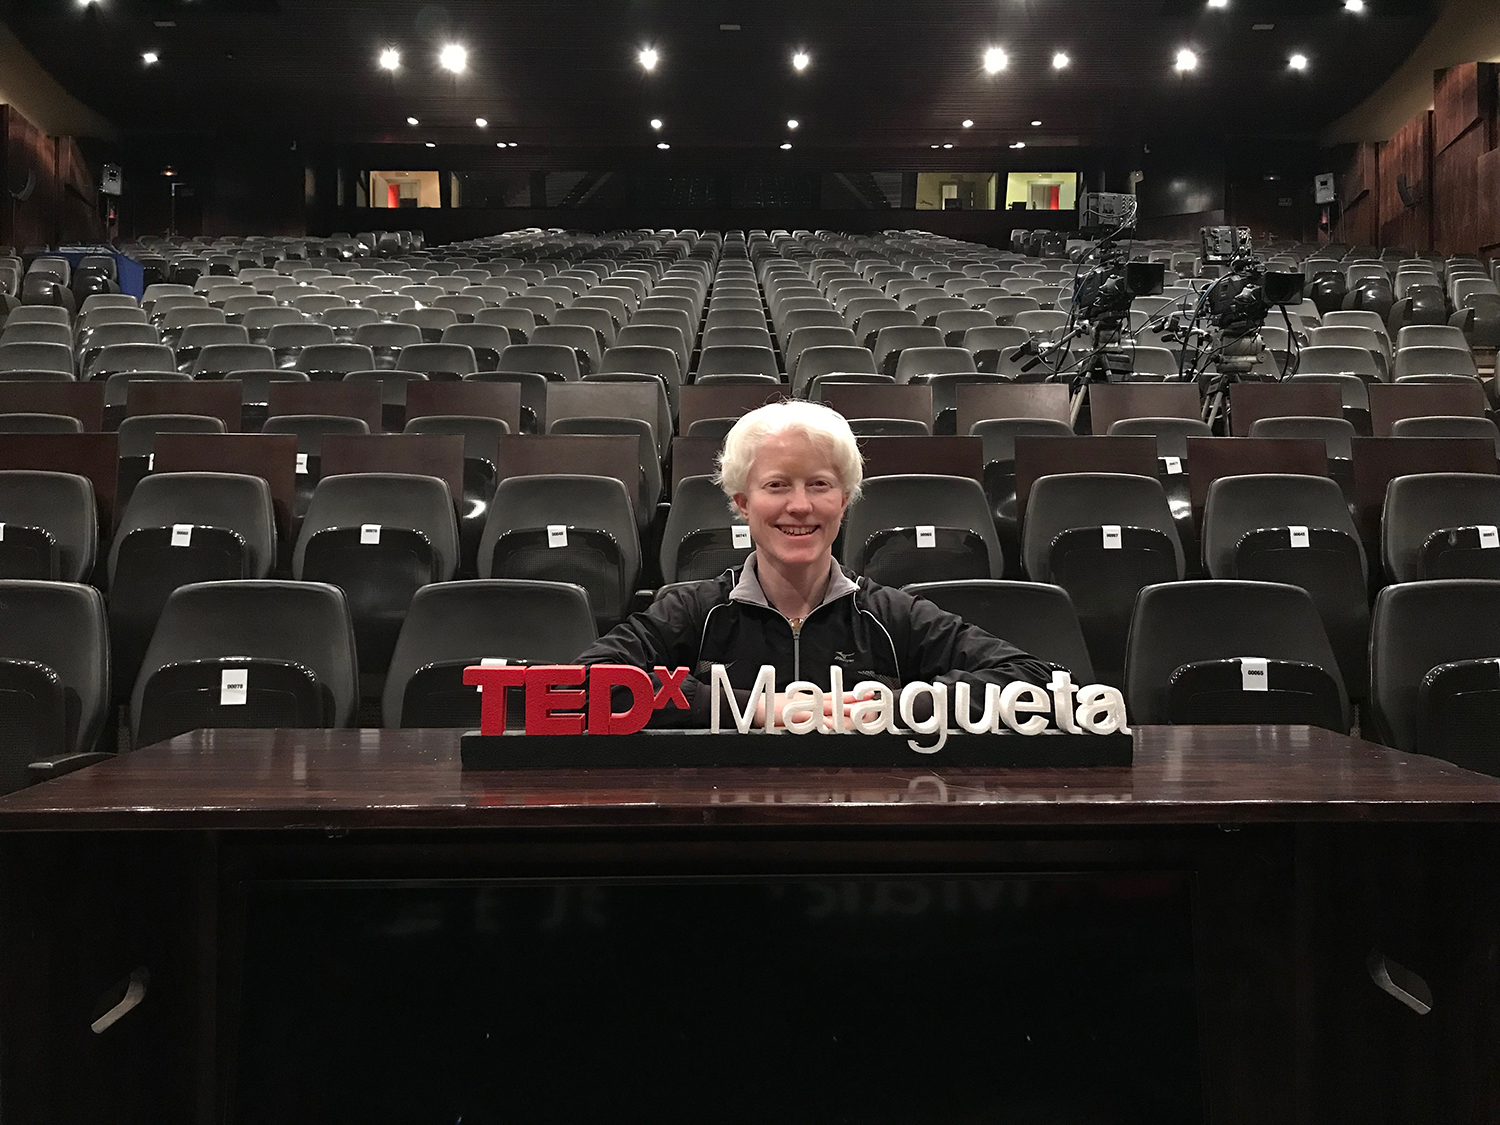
[{"x1": 578, "y1": 555, "x2": 1061, "y2": 726}]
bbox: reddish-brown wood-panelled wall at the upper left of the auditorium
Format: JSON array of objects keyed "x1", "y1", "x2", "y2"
[{"x1": 0, "y1": 105, "x2": 104, "y2": 246}]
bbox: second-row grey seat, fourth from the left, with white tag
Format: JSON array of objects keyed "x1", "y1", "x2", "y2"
[{"x1": 479, "y1": 474, "x2": 641, "y2": 632}]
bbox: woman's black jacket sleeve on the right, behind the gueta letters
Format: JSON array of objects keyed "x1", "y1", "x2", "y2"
[{"x1": 870, "y1": 587, "x2": 1068, "y2": 717}]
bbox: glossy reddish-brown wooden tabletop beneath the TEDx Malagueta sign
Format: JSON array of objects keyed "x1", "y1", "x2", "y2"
[{"x1": 0, "y1": 728, "x2": 1500, "y2": 831}]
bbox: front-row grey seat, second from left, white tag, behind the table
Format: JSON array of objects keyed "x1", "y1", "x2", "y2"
[{"x1": 131, "y1": 579, "x2": 360, "y2": 746}]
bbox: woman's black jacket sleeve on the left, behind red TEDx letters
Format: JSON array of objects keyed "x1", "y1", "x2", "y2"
[{"x1": 578, "y1": 579, "x2": 722, "y2": 728}]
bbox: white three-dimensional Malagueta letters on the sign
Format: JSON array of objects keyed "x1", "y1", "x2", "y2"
[{"x1": 708, "y1": 665, "x2": 1131, "y2": 755}]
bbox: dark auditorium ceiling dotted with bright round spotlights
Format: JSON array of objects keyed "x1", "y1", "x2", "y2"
[{"x1": 0, "y1": 0, "x2": 1437, "y2": 150}]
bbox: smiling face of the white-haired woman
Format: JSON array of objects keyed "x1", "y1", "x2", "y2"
[{"x1": 735, "y1": 434, "x2": 849, "y2": 573}]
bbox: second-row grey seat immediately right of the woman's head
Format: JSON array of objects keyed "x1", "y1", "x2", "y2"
[{"x1": 843, "y1": 474, "x2": 1005, "y2": 587}]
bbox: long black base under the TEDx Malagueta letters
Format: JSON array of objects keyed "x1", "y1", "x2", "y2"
[{"x1": 461, "y1": 731, "x2": 1134, "y2": 770}]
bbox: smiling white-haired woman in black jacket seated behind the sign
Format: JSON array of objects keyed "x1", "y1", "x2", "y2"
[{"x1": 579, "y1": 402, "x2": 1056, "y2": 726}]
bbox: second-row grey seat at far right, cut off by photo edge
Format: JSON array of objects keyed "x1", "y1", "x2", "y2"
[{"x1": 1380, "y1": 473, "x2": 1500, "y2": 582}]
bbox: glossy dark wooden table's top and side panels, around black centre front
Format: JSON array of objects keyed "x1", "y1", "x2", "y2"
[{"x1": 0, "y1": 728, "x2": 1500, "y2": 1125}]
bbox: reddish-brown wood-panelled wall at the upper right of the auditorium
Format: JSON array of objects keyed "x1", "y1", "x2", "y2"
[{"x1": 1335, "y1": 63, "x2": 1500, "y2": 258}]
